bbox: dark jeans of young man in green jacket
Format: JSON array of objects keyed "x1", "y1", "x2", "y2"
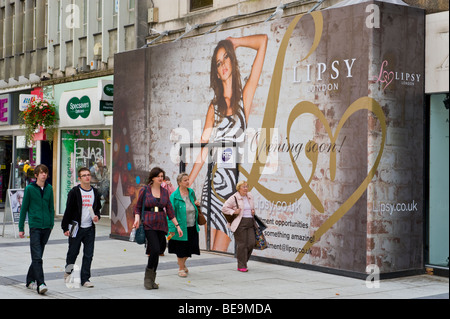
[{"x1": 26, "y1": 228, "x2": 52, "y2": 287}]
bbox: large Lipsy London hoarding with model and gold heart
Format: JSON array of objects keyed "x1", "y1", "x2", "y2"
[{"x1": 111, "y1": 1, "x2": 424, "y2": 273}]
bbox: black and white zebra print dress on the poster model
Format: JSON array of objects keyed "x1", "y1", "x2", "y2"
[{"x1": 202, "y1": 105, "x2": 247, "y2": 239}]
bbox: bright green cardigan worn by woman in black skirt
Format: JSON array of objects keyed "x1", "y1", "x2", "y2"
[{"x1": 168, "y1": 188, "x2": 200, "y2": 241}]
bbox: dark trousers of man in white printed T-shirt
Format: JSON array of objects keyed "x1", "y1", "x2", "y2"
[{"x1": 66, "y1": 226, "x2": 95, "y2": 285}]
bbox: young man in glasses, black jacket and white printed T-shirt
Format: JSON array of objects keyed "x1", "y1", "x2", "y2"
[{"x1": 61, "y1": 167, "x2": 102, "y2": 288}]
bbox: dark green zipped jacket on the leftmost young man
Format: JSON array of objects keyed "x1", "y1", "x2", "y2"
[{"x1": 19, "y1": 183, "x2": 55, "y2": 232}]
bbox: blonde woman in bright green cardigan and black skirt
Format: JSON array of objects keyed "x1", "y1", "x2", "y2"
[{"x1": 169, "y1": 173, "x2": 200, "y2": 277}]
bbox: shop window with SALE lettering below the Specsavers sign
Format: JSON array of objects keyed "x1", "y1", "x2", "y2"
[{"x1": 59, "y1": 130, "x2": 111, "y2": 216}]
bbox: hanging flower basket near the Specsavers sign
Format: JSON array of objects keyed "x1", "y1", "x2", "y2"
[{"x1": 20, "y1": 99, "x2": 59, "y2": 143}]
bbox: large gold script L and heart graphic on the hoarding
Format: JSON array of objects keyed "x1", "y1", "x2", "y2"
[{"x1": 239, "y1": 11, "x2": 387, "y2": 262}]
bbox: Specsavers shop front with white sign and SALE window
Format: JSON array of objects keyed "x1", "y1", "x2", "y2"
[{"x1": 50, "y1": 78, "x2": 112, "y2": 217}]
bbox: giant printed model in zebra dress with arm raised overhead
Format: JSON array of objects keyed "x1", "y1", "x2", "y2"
[{"x1": 189, "y1": 34, "x2": 267, "y2": 251}]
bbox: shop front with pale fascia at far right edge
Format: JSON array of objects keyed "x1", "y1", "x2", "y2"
[{"x1": 425, "y1": 11, "x2": 450, "y2": 276}]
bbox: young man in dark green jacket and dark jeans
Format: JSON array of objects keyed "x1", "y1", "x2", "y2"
[{"x1": 19, "y1": 165, "x2": 55, "y2": 294}]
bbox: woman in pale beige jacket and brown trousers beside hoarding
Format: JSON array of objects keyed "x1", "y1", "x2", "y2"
[{"x1": 222, "y1": 181, "x2": 255, "y2": 272}]
